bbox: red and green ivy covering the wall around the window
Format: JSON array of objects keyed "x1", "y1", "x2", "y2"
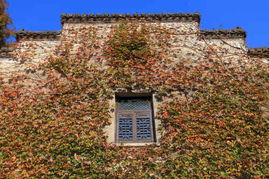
[{"x1": 0, "y1": 23, "x2": 269, "y2": 178}]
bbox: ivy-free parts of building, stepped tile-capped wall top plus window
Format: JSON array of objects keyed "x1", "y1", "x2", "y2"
[{"x1": 0, "y1": 13, "x2": 269, "y2": 146}]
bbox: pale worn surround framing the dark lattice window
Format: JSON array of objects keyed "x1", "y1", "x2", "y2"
[{"x1": 105, "y1": 93, "x2": 161, "y2": 146}]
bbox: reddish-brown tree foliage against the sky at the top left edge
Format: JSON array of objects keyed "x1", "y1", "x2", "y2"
[{"x1": 0, "y1": 0, "x2": 12, "y2": 48}]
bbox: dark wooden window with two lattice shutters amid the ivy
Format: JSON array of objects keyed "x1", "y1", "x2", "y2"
[{"x1": 116, "y1": 96, "x2": 155, "y2": 143}]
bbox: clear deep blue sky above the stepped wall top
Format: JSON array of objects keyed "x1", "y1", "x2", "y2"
[{"x1": 7, "y1": 0, "x2": 269, "y2": 47}]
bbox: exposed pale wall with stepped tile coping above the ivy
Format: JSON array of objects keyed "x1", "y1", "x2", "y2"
[{"x1": 0, "y1": 13, "x2": 269, "y2": 142}]
